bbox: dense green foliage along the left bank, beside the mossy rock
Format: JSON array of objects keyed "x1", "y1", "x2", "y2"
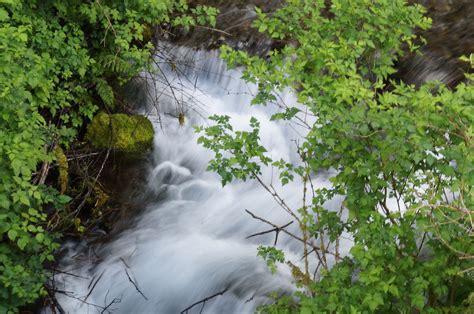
[{"x1": 0, "y1": 0, "x2": 216, "y2": 312}]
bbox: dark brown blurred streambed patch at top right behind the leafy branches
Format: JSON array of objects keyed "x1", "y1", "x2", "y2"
[{"x1": 396, "y1": 0, "x2": 474, "y2": 87}]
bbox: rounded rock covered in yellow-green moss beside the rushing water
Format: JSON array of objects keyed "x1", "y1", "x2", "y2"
[{"x1": 86, "y1": 112, "x2": 154, "y2": 156}]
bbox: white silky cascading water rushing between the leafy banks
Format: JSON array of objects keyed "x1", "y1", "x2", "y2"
[{"x1": 55, "y1": 47, "x2": 348, "y2": 313}]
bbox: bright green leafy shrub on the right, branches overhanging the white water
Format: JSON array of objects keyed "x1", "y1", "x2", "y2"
[{"x1": 198, "y1": 0, "x2": 474, "y2": 313}]
